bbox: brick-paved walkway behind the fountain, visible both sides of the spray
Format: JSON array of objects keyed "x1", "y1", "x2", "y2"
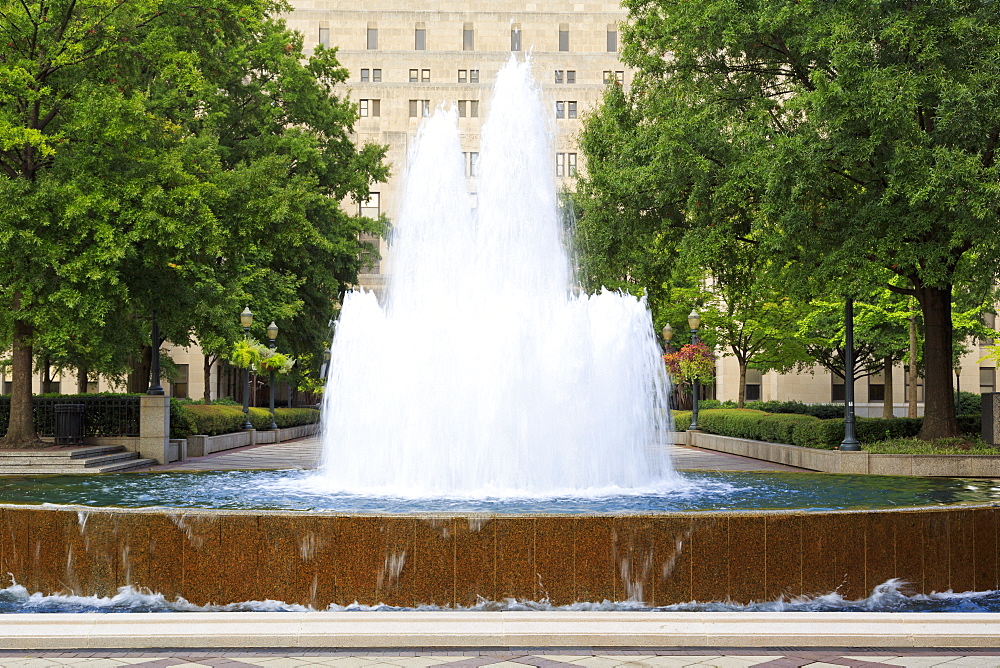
[{"x1": 149, "y1": 436, "x2": 805, "y2": 472}]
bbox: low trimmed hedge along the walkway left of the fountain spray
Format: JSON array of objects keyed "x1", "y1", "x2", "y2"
[{"x1": 170, "y1": 403, "x2": 319, "y2": 438}]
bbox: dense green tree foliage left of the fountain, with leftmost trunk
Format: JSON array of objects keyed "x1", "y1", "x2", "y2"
[{"x1": 0, "y1": 0, "x2": 387, "y2": 442}]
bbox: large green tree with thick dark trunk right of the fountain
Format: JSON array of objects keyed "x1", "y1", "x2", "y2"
[{"x1": 586, "y1": 0, "x2": 1000, "y2": 438}]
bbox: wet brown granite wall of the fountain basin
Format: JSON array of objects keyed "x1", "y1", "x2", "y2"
[{"x1": 0, "y1": 506, "x2": 1000, "y2": 607}]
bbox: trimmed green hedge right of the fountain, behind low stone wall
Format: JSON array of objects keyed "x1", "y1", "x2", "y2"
[{"x1": 674, "y1": 408, "x2": 980, "y2": 450}]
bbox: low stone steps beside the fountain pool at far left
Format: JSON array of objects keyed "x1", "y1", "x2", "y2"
[{"x1": 0, "y1": 445, "x2": 158, "y2": 475}]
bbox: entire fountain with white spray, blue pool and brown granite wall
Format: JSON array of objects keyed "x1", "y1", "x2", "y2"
[{"x1": 0, "y1": 57, "x2": 1000, "y2": 608}]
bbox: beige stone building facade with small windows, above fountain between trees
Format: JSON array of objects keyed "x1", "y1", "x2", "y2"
[{"x1": 286, "y1": 0, "x2": 630, "y2": 290}]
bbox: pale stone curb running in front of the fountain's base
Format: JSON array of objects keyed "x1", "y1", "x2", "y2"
[{"x1": 0, "y1": 611, "x2": 1000, "y2": 650}]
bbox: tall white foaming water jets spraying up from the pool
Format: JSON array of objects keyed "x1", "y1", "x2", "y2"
[{"x1": 312, "y1": 59, "x2": 676, "y2": 497}]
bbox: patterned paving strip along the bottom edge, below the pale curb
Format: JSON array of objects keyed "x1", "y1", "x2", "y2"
[{"x1": 0, "y1": 647, "x2": 1000, "y2": 668}]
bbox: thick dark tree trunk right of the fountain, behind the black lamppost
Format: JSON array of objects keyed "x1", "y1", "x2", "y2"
[{"x1": 917, "y1": 286, "x2": 962, "y2": 441}]
